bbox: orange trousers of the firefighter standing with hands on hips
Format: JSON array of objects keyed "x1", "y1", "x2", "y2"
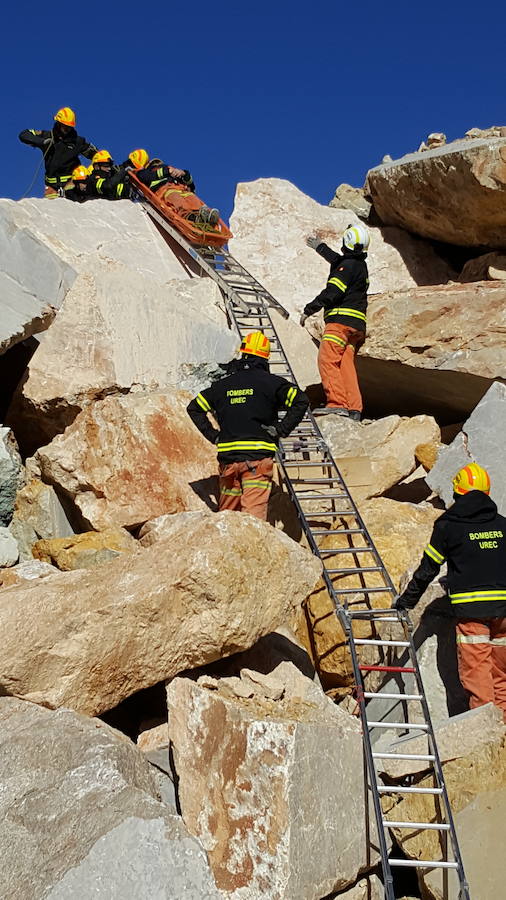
[{"x1": 219, "y1": 456, "x2": 274, "y2": 521}]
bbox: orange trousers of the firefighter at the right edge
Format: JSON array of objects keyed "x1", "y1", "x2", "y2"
[{"x1": 457, "y1": 619, "x2": 506, "y2": 717}]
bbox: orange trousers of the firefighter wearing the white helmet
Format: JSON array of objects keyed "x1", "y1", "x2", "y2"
[{"x1": 318, "y1": 322, "x2": 365, "y2": 412}]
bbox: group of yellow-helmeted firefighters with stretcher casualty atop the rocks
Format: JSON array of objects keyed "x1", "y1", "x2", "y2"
[{"x1": 19, "y1": 106, "x2": 220, "y2": 226}]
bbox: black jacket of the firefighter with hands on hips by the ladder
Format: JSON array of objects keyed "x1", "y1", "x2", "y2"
[{"x1": 187, "y1": 357, "x2": 309, "y2": 463}]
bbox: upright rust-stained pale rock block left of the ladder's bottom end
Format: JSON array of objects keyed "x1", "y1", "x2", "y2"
[{"x1": 167, "y1": 663, "x2": 374, "y2": 900}]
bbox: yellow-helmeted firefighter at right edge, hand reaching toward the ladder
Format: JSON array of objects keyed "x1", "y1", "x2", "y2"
[{"x1": 395, "y1": 463, "x2": 506, "y2": 721}]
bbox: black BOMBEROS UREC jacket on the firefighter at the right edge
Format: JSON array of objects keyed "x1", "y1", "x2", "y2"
[{"x1": 402, "y1": 491, "x2": 506, "y2": 619}]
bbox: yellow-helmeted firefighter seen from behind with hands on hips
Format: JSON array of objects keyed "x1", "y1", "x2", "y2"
[{"x1": 187, "y1": 331, "x2": 309, "y2": 519}]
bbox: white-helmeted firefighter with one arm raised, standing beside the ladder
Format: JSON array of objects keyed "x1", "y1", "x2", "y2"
[{"x1": 300, "y1": 224, "x2": 369, "y2": 421}]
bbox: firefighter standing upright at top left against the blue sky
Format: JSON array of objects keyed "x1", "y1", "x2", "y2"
[{"x1": 19, "y1": 106, "x2": 97, "y2": 199}]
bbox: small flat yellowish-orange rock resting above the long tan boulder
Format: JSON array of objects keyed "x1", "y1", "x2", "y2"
[{"x1": 32, "y1": 528, "x2": 138, "y2": 572}]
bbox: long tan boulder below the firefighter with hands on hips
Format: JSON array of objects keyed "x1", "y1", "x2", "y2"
[{"x1": 0, "y1": 513, "x2": 321, "y2": 715}]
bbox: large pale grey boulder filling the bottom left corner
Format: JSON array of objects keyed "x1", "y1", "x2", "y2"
[{"x1": 0, "y1": 697, "x2": 219, "y2": 900}]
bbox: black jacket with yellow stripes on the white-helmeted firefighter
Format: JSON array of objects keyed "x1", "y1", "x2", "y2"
[{"x1": 304, "y1": 244, "x2": 369, "y2": 331}]
